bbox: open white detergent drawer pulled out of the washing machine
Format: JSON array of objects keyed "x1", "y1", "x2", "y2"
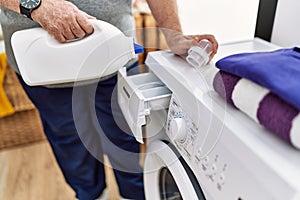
[{"x1": 118, "y1": 68, "x2": 171, "y2": 143}]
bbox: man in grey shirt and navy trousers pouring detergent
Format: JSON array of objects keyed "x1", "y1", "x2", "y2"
[{"x1": 0, "y1": 0, "x2": 217, "y2": 200}]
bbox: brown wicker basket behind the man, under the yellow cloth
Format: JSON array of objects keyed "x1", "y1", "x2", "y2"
[{"x1": 0, "y1": 63, "x2": 46, "y2": 149}]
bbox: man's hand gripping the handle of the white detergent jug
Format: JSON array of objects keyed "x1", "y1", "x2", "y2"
[{"x1": 31, "y1": 0, "x2": 95, "y2": 43}]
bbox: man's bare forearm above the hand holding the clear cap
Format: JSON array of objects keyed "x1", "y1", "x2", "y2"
[{"x1": 147, "y1": 0, "x2": 182, "y2": 33}]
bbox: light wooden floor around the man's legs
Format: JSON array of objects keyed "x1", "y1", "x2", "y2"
[{"x1": 0, "y1": 141, "x2": 119, "y2": 200}]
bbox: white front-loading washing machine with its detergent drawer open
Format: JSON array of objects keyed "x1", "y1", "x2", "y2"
[{"x1": 118, "y1": 38, "x2": 300, "y2": 200}]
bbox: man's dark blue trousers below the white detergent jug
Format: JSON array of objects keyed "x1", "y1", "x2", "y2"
[{"x1": 19, "y1": 68, "x2": 144, "y2": 200}]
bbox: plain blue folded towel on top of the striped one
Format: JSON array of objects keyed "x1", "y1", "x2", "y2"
[{"x1": 216, "y1": 47, "x2": 300, "y2": 110}]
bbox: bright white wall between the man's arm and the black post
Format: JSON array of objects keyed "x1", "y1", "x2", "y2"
[{"x1": 177, "y1": 0, "x2": 258, "y2": 43}]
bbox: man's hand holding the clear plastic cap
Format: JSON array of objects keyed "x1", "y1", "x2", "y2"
[{"x1": 163, "y1": 30, "x2": 218, "y2": 60}]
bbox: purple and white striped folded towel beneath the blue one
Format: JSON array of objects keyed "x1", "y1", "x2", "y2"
[{"x1": 213, "y1": 71, "x2": 300, "y2": 149}]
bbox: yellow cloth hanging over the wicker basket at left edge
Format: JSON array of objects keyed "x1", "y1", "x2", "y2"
[{"x1": 0, "y1": 53, "x2": 14, "y2": 118}]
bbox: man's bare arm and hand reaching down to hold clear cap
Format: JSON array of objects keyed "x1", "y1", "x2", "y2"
[{"x1": 147, "y1": 0, "x2": 218, "y2": 58}]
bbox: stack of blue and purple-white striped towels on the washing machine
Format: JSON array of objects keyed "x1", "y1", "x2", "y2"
[{"x1": 213, "y1": 47, "x2": 300, "y2": 149}]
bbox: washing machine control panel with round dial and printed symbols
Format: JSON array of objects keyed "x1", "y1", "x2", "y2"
[{"x1": 166, "y1": 95, "x2": 228, "y2": 191}]
